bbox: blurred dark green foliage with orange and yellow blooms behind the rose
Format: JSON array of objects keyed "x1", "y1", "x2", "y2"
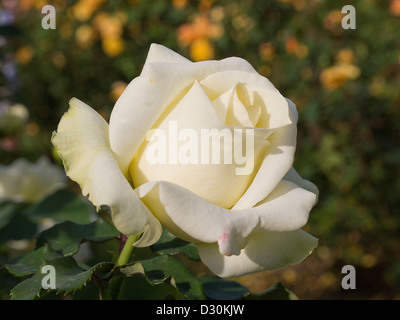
[{"x1": 0, "y1": 0, "x2": 400, "y2": 299}]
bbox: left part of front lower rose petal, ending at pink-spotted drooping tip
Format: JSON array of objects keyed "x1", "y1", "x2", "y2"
[{"x1": 136, "y1": 181, "x2": 258, "y2": 254}]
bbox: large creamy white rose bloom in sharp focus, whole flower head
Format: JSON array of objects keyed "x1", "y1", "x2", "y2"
[{"x1": 52, "y1": 44, "x2": 318, "y2": 277}]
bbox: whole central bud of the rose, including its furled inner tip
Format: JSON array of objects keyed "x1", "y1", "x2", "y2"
[{"x1": 130, "y1": 81, "x2": 269, "y2": 208}]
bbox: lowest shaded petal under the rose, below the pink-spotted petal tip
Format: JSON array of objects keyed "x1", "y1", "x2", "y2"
[{"x1": 197, "y1": 230, "x2": 318, "y2": 278}]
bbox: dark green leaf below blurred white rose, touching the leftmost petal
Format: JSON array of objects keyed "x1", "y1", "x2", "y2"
[{"x1": 26, "y1": 189, "x2": 90, "y2": 223}]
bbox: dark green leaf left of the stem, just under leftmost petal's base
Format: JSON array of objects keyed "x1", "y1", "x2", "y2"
[{"x1": 36, "y1": 219, "x2": 120, "y2": 255}]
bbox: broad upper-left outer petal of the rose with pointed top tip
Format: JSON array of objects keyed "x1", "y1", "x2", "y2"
[{"x1": 110, "y1": 46, "x2": 255, "y2": 174}]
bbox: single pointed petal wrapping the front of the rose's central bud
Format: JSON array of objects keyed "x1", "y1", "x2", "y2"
[{"x1": 130, "y1": 81, "x2": 268, "y2": 208}]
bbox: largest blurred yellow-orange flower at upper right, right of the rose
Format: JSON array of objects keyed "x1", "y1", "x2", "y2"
[{"x1": 320, "y1": 64, "x2": 361, "y2": 90}]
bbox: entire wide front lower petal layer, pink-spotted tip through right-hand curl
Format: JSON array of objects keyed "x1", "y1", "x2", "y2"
[{"x1": 136, "y1": 181, "x2": 316, "y2": 255}]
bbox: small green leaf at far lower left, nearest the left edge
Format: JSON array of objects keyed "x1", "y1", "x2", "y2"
[{"x1": 4, "y1": 245, "x2": 62, "y2": 277}]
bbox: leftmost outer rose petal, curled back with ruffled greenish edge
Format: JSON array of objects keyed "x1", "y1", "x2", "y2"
[{"x1": 52, "y1": 98, "x2": 161, "y2": 239}]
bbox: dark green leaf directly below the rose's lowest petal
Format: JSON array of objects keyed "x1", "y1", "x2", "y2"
[{"x1": 199, "y1": 275, "x2": 250, "y2": 300}]
